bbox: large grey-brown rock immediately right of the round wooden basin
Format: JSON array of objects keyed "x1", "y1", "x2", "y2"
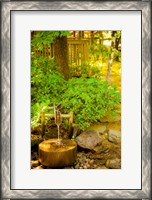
[{"x1": 76, "y1": 130, "x2": 102, "y2": 150}]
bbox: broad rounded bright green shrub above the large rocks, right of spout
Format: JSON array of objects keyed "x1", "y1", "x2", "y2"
[{"x1": 61, "y1": 78, "x2": 120, "y2": 130}]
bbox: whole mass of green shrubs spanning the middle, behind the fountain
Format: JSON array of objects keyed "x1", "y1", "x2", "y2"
[{"x1": 31, "y1": 57, "x2": 120, "y2": 130}]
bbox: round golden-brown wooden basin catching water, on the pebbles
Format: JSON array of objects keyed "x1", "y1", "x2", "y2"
[{"x1": 39, "y1": 138, "x2": 77, "y2": 168}]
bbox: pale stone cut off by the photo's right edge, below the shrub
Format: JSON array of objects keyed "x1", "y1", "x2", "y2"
[{"x1": 108, "y1": 130, "x2": 121, "y2": 144}]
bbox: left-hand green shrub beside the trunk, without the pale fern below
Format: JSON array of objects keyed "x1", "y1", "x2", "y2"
[{"x1": 31, "y1": 57, "x2": 65, "y2": 103}]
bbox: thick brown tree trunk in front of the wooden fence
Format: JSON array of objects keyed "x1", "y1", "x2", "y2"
[{"x1": 54, "y1": 36, "x2": 69, "y2": 80}]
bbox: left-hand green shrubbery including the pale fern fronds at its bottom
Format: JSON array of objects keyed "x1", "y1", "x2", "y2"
[{"x1": 31, "y1": 56, "x2": 66, "y2": 128}]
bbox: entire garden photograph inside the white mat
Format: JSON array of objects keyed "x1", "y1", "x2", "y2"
[{"x1": 31, "y1": 30, "x2": 121, "y2": 169}]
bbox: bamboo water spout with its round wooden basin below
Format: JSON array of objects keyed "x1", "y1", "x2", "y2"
[{"x1": 38, "y1": 105, "x2": 77, "y2": 168}]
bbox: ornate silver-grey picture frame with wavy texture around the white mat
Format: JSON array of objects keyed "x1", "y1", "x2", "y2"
[{"x1": 1, "y1": 1, "x2": 151, "y2": 199}]
